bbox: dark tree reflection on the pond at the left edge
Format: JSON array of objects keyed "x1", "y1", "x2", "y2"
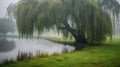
[{"x1": 0, "y1": 38, "x2": 15, "y2": 52}]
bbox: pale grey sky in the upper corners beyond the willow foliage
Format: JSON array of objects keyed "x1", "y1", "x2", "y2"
[{"x1": 0, "y1": 0, "x2": 120, "y2": 18}]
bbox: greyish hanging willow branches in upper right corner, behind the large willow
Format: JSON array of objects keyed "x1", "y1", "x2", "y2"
[{"x1": 97, "y1": 0, "x2": 120, "y2": 34}]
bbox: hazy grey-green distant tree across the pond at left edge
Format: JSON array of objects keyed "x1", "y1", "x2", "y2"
[{"x1": 0, "y1": 18, "x2": 15, "y2": 35}]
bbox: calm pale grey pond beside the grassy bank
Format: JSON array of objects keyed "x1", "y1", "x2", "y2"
[{"x1": 0, "y1": 38, "x2": 75, "y2": 63}]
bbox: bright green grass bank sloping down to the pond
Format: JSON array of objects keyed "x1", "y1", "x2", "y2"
[{"x1": 0, "y1": 38, "x2": 120, "y2": 67}]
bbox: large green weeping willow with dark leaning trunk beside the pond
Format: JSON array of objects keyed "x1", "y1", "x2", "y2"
[{"x1": 8, "y1": 0, "x2": 115, "y2": 44}]
